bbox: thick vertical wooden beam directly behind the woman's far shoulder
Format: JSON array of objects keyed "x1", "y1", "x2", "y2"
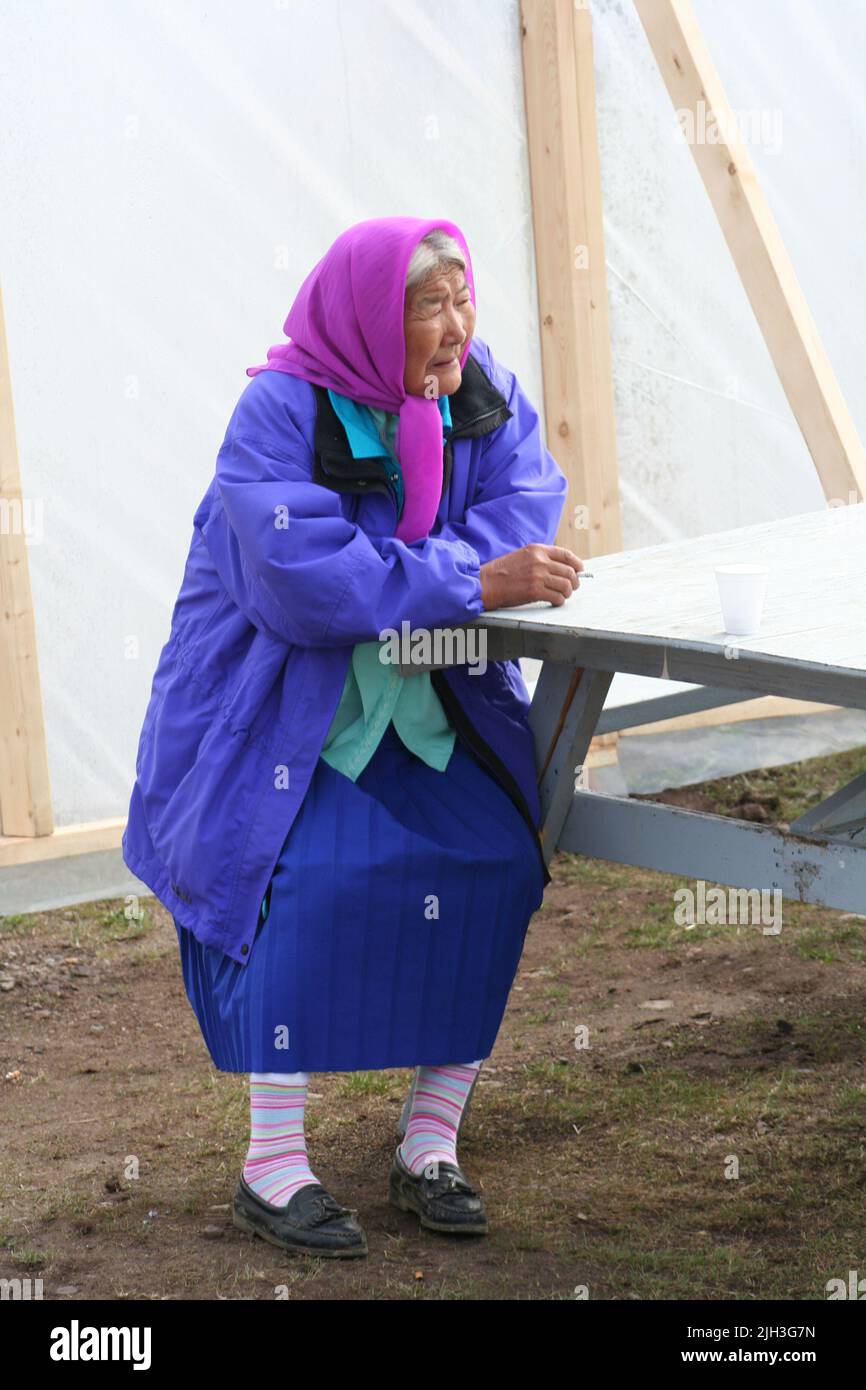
[{"x1": 520, "y1": 0, "x2": 623, "y2": 556}]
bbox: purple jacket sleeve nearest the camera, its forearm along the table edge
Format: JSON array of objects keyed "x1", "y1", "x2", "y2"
[{"x1": 202, "y1": 425, "x2": 482, "y2": 646}]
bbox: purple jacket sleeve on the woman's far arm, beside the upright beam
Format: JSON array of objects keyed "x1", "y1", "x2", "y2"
[{"x1": 439, "y1": 363, "x2": 569, "y2": 564}]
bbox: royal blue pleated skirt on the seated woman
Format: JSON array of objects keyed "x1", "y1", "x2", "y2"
[{"x1": 175, "y1": 724, "x2": 544, "y2": 1072}]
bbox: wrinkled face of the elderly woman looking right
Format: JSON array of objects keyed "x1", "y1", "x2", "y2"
[{"x1": 403, "y1": 265, "x2": 475, "y2": 398}]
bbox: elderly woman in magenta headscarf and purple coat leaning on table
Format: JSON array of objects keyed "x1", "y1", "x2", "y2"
[{"x1": 124, "y1": 217, "x2": 582, "y2": 1257}]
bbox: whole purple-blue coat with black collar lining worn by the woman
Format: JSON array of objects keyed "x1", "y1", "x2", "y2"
[{"x1": 122, "y1": 338, "x2": 567, "y2": 963}]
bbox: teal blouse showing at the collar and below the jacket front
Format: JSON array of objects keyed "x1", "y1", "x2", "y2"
[{"x1": 321, "y1": 391, "x2": 456, "y2": 781}]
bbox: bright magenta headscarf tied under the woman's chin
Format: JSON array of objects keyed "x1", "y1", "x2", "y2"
[{"x1": 246, "y1": 217, "x2": 475, "y2": 542}]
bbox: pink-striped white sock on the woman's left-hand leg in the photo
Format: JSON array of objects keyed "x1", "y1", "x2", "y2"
[{"x1": 243, "y1": 1072, "x2": 318, "y2": 1207}]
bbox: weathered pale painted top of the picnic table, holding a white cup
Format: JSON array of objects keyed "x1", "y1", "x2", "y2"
[{"x1": 447, "y1": 502, "x2": 866, "y2": 709}]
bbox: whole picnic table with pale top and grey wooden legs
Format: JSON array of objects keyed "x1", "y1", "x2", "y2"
[{"x1": 398, "y1": 503, "x2": 866, "y2": 1134}]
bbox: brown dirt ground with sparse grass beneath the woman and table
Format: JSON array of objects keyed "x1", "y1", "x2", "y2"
[{"x1": 0, "y1": 749, "x2": 866, "y2": 1301}]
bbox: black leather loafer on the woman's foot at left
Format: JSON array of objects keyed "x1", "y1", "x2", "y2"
[{"x1": 232, "y1": 1175, "x2": 367, "y2": 1259}]
